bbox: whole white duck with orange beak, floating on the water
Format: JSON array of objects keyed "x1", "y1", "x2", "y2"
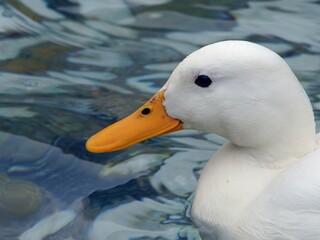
[{"x1": 86, "y1": 41, "x2": 320, "y2": 240}]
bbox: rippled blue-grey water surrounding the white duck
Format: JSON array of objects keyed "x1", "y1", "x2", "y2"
[{"x1": 0, "y1": 0, "x2": 320, "y2": 240}]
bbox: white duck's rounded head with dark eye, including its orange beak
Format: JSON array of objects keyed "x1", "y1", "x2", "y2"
[{"x1": 86, "y1": 41, "x2": 315, "y2": 158}]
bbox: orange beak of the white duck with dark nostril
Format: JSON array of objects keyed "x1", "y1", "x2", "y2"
[{"x1": 86, "y1": 91, "x2": 183, "y2": 153}]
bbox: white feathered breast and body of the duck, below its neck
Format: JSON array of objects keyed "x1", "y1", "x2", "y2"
[{"x1": 191, "y1": 140, "x2": 320, "y2": 240}]
